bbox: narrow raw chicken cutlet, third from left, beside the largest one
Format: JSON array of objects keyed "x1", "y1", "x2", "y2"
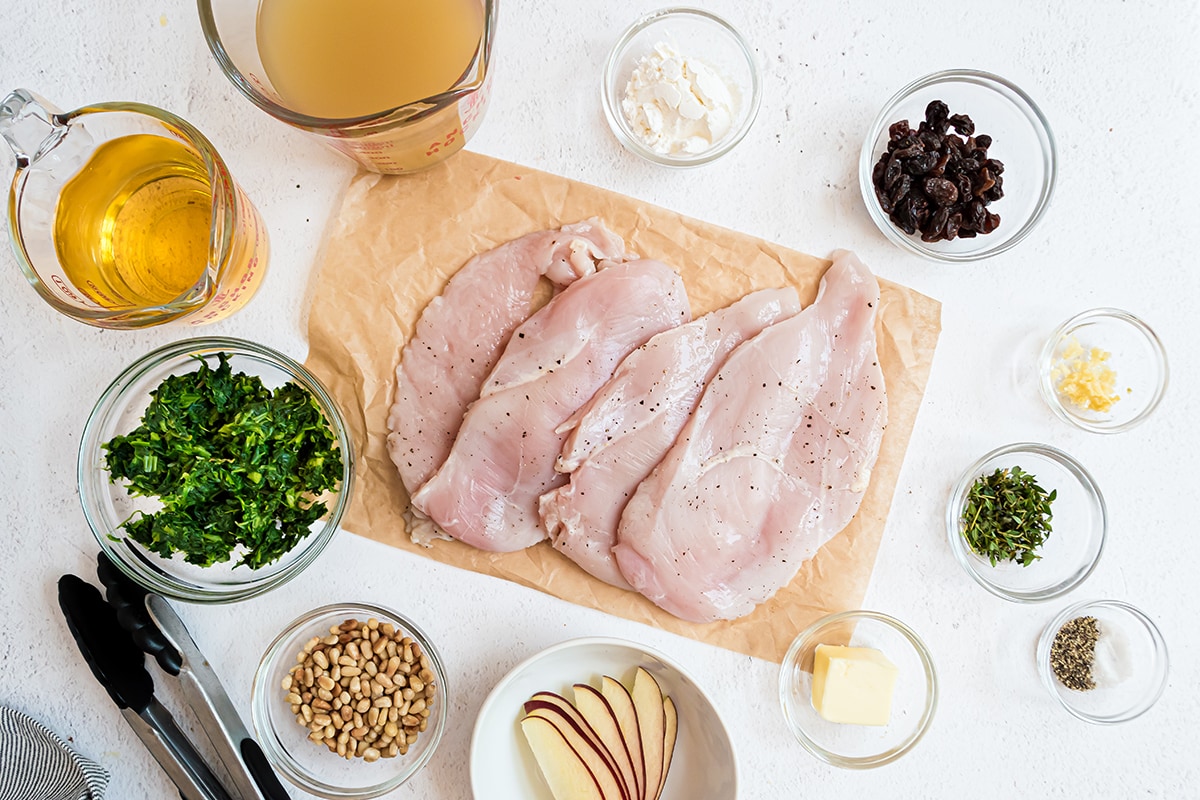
[{"x1": 539, "y1": 289, "x2": 800, "y2": 589}]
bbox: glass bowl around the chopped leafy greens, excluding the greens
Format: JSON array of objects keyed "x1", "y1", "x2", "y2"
[{"x1": 78, "y1": 337, "x2": 354, "y2": 603}]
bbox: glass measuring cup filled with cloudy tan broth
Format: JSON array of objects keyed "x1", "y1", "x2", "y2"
[{"x1": 198, "y1": 0, "x2": 497, "y2": 174}]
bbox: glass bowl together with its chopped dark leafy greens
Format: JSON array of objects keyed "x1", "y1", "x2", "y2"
[{"x1": 79, "y1": 337, "x2": 353, "y2": 602}]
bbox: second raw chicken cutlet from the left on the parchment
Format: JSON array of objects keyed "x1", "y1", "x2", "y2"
[{"x1": 413, "y1": 259, "x2": 691, "y2": 552}]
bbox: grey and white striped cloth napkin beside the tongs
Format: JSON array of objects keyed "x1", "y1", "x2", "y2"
[{"x1": 0, "y1": 705, "x2": 108, "y2": 800}]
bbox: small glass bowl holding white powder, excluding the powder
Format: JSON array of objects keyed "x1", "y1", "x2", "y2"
[{"x1": 600, "y1": 7, "x2": 762, "y2": 167}]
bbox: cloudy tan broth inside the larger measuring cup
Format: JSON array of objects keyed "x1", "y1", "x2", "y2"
[{"x1": 256, "y1": 0, "x2": 484, "y2": 119}]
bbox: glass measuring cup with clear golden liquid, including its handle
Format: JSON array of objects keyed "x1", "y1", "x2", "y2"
[{"x1": 0, "y1": 89, "x2": 268, "y2": 329}]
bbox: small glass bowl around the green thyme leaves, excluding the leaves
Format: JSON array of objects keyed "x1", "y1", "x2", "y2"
[{"x1": 946, "y1": 443, "x2": 1108, "y2": 603}]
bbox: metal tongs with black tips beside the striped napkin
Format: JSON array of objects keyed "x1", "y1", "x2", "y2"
[{"x1": 59, "y1": 553, "x2": 288, "y2": 800}]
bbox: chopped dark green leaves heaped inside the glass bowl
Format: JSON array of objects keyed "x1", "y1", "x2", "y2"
[{"x1": 103, "y1": 353, "x2": 342, "y2": 569}]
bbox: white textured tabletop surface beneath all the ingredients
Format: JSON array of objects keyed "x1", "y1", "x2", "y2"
[{"x1": 0, "y1": 0, "x2": 1200, "y2": 800}]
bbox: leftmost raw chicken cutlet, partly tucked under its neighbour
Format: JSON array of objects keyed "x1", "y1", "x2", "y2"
[{"x1": 388, "y1": 219, "x2": 634, "y2": 541}]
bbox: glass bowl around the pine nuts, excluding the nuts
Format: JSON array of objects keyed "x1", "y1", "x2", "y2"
[{"x1": 250, "y1": 603, "x2": 449, "y2": 800}]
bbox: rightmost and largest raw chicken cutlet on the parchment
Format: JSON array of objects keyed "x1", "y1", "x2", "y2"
[{"x1": 613, "y1": 252, "x2": 887, "y2": 622}]
